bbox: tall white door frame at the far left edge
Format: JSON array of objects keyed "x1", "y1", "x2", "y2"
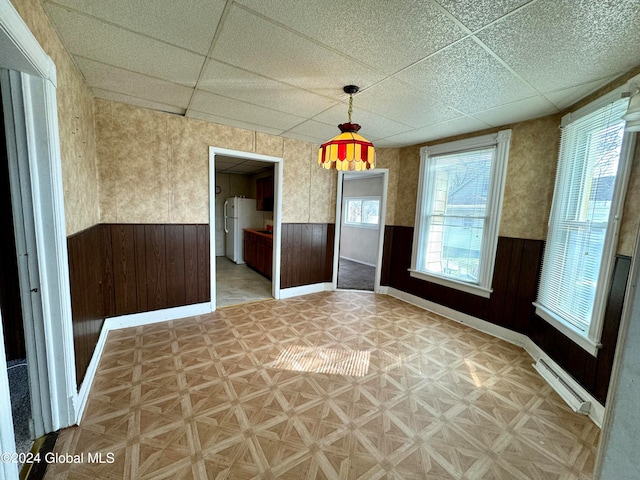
[{"x1": 0, "y1": 0, "x2": 78, "y2": 480}]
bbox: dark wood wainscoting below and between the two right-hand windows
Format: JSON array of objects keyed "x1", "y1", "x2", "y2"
[{"x1": 382, "y1": 226, "x2": 631, "y2": 404}]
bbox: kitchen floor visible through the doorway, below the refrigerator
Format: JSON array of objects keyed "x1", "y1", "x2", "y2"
[{"x1": 216, "y1": 257, "x2": 272, "y2": 308}]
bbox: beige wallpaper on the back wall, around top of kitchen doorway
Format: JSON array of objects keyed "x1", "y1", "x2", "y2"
[{"x1": 95, "y1": 100, "x2": 336, "y2": 223}]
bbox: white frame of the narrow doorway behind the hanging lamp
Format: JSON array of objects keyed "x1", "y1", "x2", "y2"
[{"x1": 332, "y1": 168, "x2": 389, "y2": 293}]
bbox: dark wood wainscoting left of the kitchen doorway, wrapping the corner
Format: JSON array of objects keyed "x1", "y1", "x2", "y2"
[{"x1": 67, "y1": 224, "x2": 211, "y2": 384}]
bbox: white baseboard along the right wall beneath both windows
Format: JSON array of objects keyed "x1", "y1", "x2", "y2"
[{"x1": 386, "y1": 287, "x2": 605, "y2": 428}]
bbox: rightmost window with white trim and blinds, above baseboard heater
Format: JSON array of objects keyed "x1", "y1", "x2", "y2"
[{"x1": 535, "y1": 96, "x2": 629, "y2": 355}]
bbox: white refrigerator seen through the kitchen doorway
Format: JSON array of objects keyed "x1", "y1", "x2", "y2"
[{"x1": 224, "y1": 197, "x2": 264, "y2": 264}]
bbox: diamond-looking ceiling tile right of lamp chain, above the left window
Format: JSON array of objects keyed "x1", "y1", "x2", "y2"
[{"x1": 396, "y1": 38, "x2": 535, "y2": 114}]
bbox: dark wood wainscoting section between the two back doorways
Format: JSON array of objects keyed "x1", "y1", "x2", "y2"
[{"x1": 280, "y1": 223, "x2": 335, "y2": 288}]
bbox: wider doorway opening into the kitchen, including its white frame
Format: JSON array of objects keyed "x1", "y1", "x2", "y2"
[{"x1": 210, "y1": 147, "x2": 281, "y2": 308}]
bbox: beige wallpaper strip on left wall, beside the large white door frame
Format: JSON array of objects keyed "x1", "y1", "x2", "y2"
[{"x1": 11, "y1": 0, "x2": 100, "y2": 235}]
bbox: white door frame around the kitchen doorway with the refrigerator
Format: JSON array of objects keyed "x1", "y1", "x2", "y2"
[{"x1": 209, "y1": 147, "x2": 282, "y2": 310}]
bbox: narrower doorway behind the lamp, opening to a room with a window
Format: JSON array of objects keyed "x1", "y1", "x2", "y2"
[{"x1": 334, "y1": 169, "x2": 388, "y2": 292}]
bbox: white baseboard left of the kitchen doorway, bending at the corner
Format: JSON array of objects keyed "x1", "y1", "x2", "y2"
[{"x1": 76, "y1": 302, "x2": 213, "y2": 423}]
